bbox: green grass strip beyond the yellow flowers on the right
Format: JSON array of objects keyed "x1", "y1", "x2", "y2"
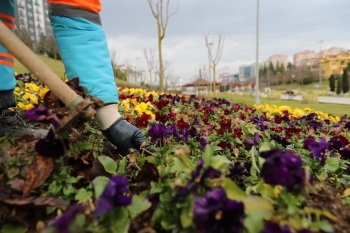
[{"x1": 206, "y1": 93, "x2": 350, "y2": 116}]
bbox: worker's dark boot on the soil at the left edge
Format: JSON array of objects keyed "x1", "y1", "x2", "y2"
[{"x1": 0, "y1": 109, "x2": 49, "y2": 139}]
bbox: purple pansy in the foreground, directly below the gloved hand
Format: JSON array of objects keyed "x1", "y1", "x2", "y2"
[{"x1": 93, "y1": 175, "x2": 132, "y2": 217}]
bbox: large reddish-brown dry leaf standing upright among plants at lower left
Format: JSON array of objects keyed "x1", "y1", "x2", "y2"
[{"x1": 23, "y1": 155, "x2": 53, "y2": 197}]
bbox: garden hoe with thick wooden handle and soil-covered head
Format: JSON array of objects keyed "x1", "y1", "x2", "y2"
[{"x1": 0, "y1": 21, "x2": 96, "y2": 132}]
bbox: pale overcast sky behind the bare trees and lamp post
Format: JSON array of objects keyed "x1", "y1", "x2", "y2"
[{"x1": 101, "y1": 0, "x2": 350, "y2": 82}]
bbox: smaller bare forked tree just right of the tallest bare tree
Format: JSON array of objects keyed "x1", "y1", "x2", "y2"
[{"x1": 204, "y1": 34, "x2": 225, "y2": 95}]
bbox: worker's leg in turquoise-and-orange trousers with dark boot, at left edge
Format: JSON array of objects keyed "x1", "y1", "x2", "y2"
[{"x1": 0, "y1": 0, "x2": 48, "y2": 138}]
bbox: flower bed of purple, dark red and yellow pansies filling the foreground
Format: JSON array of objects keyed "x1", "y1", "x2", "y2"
[{"x1": 0, "y1": 74, "x2": 350, "y2": 233}]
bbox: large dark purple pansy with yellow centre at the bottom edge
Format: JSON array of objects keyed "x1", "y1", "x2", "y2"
[{"x1": 193, "y1": 188, "x2": 244, "y2": 233}]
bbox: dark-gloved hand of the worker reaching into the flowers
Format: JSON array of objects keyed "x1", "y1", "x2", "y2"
[{"x1": 101, "y1": 117, "x2": 146, "y2": 156}]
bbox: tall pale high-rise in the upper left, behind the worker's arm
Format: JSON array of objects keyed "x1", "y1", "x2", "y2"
[{"x1": 16, "y1": 0, "x2": 53, "y2": 43}]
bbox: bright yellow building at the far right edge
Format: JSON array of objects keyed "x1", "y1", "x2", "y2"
[{"x1": 321, "y1": 52, "x2": 350, "y2": 79}]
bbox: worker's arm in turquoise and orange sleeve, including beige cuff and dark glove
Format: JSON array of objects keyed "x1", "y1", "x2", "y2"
[{"x1": 48, "y1": 0, "x2": 145, "y2": 155}]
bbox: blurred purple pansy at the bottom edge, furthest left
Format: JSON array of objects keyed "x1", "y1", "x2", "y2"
[{"x1": 49, "y1": 205, "x2": 85, "y2": 233}]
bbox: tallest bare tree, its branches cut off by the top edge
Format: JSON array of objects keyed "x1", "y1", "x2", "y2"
[{"x1": 148, "y1": 0, "x2": 179, "y2": 91}]
